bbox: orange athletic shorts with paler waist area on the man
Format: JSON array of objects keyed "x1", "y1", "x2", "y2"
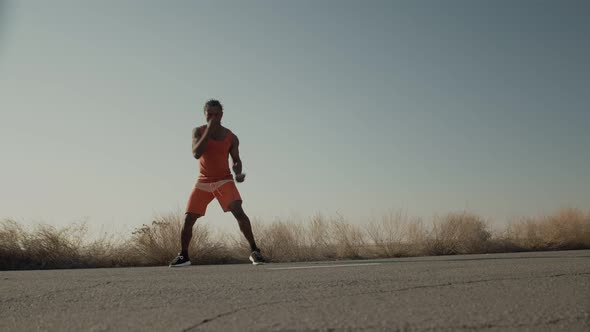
[{"x1": 186, "y1": 180, "x2": 242, "y2": 216}]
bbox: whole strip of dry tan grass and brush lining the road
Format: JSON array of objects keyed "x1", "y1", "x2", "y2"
[{"x1": 0, "y1": 209, "x2": 590, "y2": 270}]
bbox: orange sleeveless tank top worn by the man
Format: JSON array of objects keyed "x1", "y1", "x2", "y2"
[{"x1": 197, "y1": 127, "x2": 233, "y2": 183}]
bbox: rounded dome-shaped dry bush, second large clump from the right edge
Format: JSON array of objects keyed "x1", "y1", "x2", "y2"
[{"x1": 425, "y1": 212, "x2": 491, "y2": 255}]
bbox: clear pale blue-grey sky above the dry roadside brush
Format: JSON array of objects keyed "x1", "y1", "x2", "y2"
[{"x1": 0, "y1": 0, "x2": 590, "y2": 233}]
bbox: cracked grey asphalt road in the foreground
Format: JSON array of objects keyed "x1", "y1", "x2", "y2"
[{"x1": 0, "y1": 250, "x2": 590, "y2": 331}]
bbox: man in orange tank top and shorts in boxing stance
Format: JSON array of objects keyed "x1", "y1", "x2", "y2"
[{"x1": 170, "y1": 99, "x2": 265, "y2": 267}]
